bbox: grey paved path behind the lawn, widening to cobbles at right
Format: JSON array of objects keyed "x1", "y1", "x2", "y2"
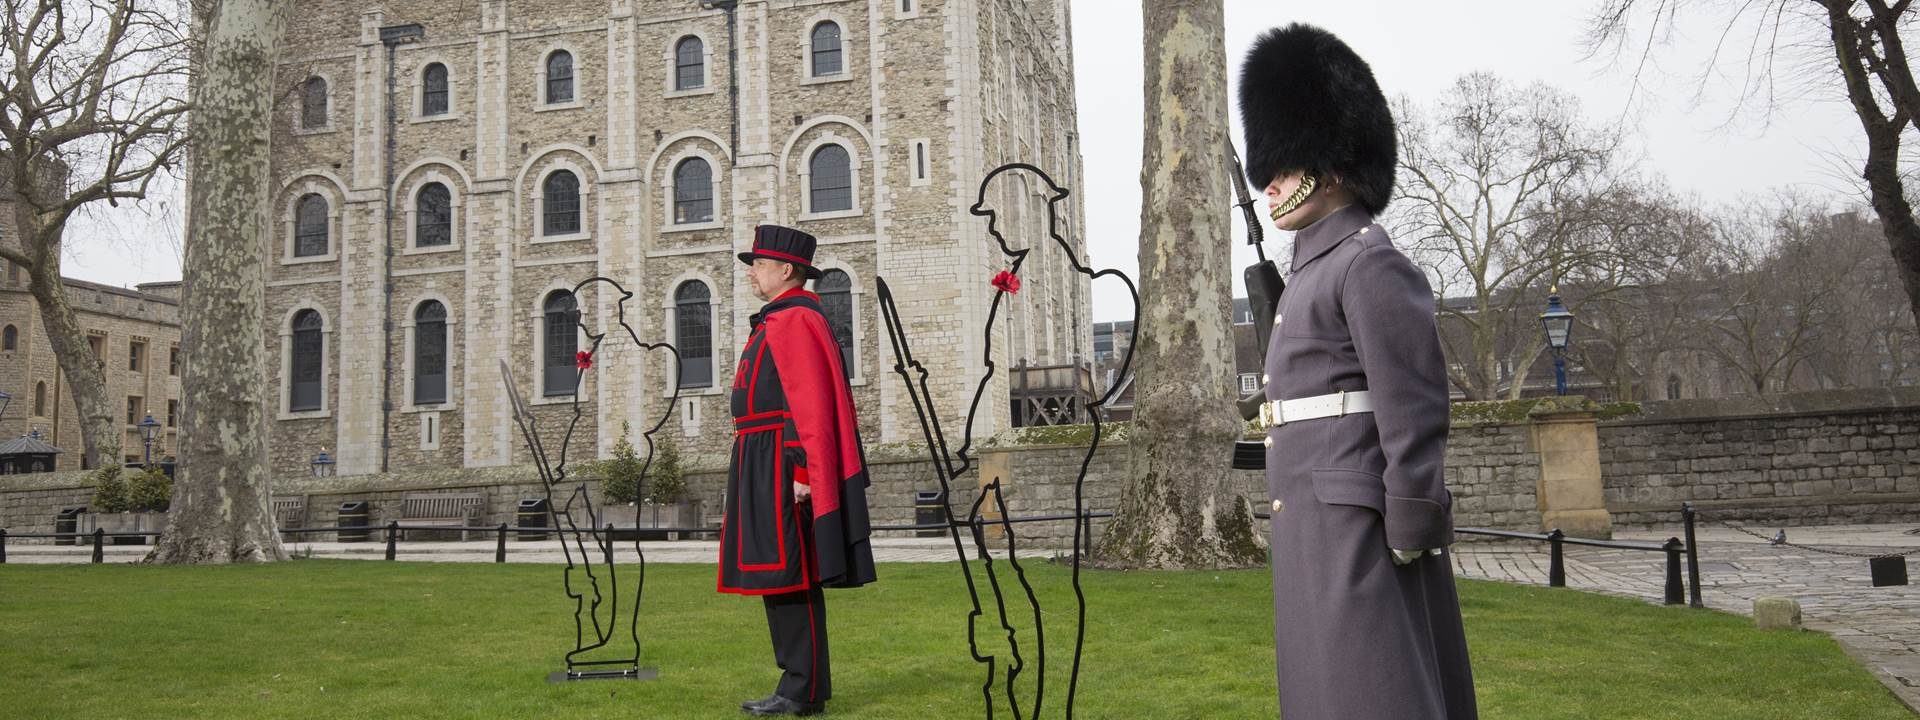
[{"x1": 8, "y1": 524, "x2": 1920, "y2": 712}]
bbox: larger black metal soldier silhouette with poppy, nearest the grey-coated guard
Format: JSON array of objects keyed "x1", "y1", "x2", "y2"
[{"x1": 876, "y1": 163, "x2": 1140, "y2": 720}]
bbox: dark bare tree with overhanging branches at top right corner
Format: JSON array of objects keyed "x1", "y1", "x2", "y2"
[{"x1": 1588, "y1": 0, "x2": 1920, "y2": 343}]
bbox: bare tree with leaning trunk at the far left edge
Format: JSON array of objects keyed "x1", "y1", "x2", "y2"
[{"x1": 0, "y1": 0, "x2": 188, "y2": 467}]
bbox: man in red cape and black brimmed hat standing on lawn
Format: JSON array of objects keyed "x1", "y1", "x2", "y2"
[{"x1": 720, "y1": 225, "x2": 874, "y2": 716}]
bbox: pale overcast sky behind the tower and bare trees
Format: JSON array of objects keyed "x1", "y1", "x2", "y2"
[{"x1": 63, "y1": 0, "x2": 1864, "y2": 321}]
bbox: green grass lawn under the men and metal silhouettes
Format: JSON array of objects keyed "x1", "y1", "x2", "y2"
[{"x1": 0, "y1": 561, "x2": 1910, "y2": 720}]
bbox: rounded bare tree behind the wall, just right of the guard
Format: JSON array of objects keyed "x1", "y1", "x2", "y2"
[{"x1": 1390, "y1": 73, "x2": 1619, "y2": 399}]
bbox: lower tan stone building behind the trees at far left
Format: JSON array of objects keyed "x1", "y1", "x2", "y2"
[{"x1": 0, "y1": 268, "x2": 184, "y2": 470}]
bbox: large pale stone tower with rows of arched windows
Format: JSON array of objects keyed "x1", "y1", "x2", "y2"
[{"x1": 267, "y1": 0, "x2": 1092, "y2": 481}]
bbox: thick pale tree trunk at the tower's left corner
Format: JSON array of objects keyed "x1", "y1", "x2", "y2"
[{"x1": 150, "y1": 0, "x2": 290, "y2": 563}]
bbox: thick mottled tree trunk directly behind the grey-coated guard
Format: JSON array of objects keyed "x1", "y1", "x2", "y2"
[{"x1": 1100, "y1": 0, "x2": 1265, "y2": 568}]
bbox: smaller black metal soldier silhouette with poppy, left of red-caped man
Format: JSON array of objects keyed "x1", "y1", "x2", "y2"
[{"x1": 499, "y1": 276, "x2": 680, "y2": 682}]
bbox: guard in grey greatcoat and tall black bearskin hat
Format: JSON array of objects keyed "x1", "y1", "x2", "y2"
[{"x1": 1240, "y1": 25, "x2": 1476, "y2": 720}]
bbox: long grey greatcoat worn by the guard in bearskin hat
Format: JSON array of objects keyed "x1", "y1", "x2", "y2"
[{"x1": 1265, "y1": 204, "x2": 1476, "y2": 720}]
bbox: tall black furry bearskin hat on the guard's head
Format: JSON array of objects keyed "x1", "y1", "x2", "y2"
[{"x1": 1240, "y1": 23, "x2": 1396, "y2": 215}]
